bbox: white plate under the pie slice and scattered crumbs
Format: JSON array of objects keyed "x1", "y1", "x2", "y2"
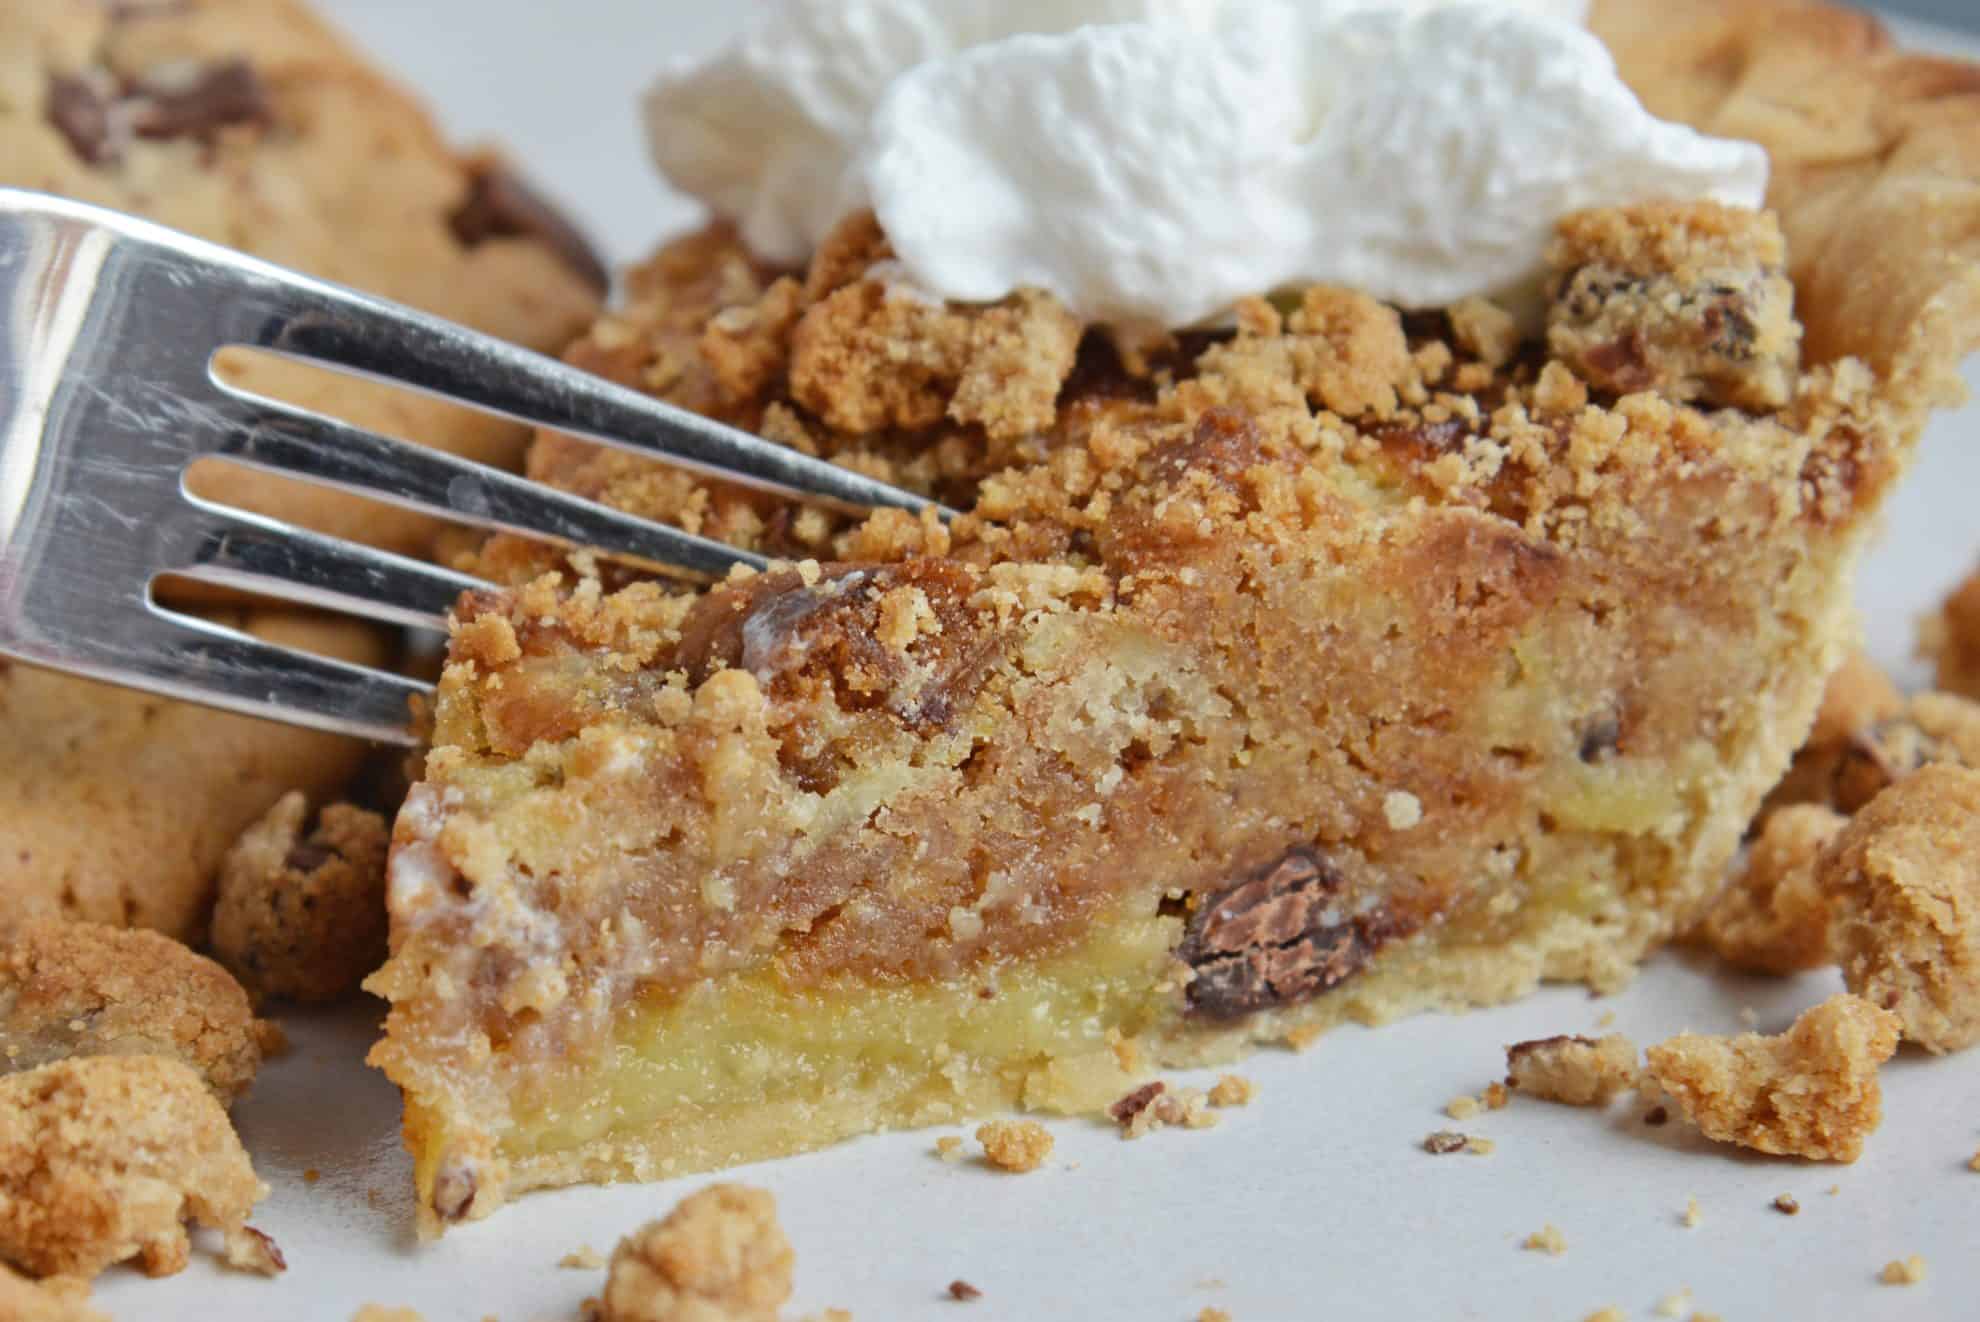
[{"x1": 99, "y1": 10, "x2": 1980, "y2": 1322}]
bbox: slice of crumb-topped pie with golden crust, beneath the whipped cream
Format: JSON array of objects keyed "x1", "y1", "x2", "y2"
[{"x1": 370, "y1": 0, "x2": 1980, "y2": 1229}]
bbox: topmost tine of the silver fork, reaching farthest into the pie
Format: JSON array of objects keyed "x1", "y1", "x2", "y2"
[{"x1": 220, "y1": 261, "x2": 956, "y2": 519}]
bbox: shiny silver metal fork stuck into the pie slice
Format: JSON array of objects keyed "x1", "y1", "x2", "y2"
[{"x1": 0, "y1": 190, "x2": 950, "y2": 744}]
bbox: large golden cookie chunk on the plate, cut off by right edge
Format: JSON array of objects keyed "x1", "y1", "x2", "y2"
[{"x1": 1822, "y1": 766, "x2": 1980, "y2": 1053}]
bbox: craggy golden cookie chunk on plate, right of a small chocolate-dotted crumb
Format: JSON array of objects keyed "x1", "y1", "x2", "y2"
[{"x1": 1645, "y1": 992, "x2": 1899, "y2": 1162}]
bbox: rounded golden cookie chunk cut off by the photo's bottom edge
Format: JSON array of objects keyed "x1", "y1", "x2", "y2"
[{"x1": 598, "y1": 1183, "x2": 796, "y2": 1322}]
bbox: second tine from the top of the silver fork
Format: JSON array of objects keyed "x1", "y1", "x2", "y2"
[{"x1": 210, "y1": 380, "x2": 768, "y2": 578}]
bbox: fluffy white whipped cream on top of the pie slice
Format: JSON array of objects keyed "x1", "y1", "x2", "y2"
[{"x1": 645, "y1": 0, "x2": 1766, "y2": 327}]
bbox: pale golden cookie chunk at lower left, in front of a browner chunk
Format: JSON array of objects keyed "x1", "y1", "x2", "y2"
[{"x1": 0, "y1": 1057, "x2": 273, "y2": 1276}]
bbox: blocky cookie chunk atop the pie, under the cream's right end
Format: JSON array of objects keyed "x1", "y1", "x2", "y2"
[{"x1": 1546, "y1": 204, "x2": 1802, "y2": 410}]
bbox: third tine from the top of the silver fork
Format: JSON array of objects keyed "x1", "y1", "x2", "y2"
[{"x1": 162, "y1": 495, "x2": 489, "y2": 629}]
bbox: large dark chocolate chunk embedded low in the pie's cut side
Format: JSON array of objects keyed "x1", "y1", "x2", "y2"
[{"x1": 1176, "y1": 845, "x2": 1394, "y2": 1019}]
